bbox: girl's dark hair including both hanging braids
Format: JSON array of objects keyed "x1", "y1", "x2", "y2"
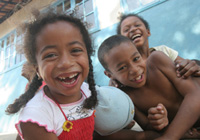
[{"x1": 6, "y1": 11, "x2": 97, "y2": 114}]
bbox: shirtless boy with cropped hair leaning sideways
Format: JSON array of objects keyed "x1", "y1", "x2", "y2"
[{"x1": 98, "y1": 35, "x2": 200, "y2": 140}]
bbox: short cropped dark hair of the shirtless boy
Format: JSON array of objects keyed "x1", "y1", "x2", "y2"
[{"x1": 98, "y1": 35, "x2": 132, "y2": 71}]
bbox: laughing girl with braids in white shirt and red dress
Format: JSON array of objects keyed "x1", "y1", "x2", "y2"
[{"x1": 6, "y1": 10, "x2": 97, "y2": 140}]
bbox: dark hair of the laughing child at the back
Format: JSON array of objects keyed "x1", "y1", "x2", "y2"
[{"x1": 117, "y1": 14, "x2": 150, "y2": 34}]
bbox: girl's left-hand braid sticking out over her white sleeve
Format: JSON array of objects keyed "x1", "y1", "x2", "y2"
[{"x1": 6, "y1": 74, "x2": 42, "y2": 114}]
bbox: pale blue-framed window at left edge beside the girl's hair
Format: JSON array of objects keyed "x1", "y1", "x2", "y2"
[{"x1": 0, "y1": 31, "x2": 25, "y2": 72}]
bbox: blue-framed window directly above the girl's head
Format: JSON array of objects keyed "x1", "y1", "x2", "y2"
[{"x1": 55, "y1": 0, "x2": 99, "y2": 33}]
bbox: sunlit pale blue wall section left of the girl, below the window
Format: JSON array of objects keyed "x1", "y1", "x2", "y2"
[{"x1": 0, "y1": 67, "x2": 27, "y2": 133}]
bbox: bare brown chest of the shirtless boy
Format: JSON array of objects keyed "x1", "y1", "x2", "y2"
[{"x1": 127, "y1": 71, "x2": 182, "y2": 113}]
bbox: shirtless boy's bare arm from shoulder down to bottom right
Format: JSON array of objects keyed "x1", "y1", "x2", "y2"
[{"x1": 148, "y1": 52, "x2": 200, "y2": 140}]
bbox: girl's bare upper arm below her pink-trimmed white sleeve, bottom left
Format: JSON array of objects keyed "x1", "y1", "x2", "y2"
[{"x1": 20, "y1": 122, "x2": 58, "y2": 140}]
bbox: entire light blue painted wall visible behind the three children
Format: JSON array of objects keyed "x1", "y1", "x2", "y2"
[{"x1": 0, "y1": 0, "x2": 200, "y2": 133}]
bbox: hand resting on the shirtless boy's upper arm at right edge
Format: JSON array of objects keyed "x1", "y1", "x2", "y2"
[{"x1": 175, "y1": 59, "x2": 200, "y2": 78}]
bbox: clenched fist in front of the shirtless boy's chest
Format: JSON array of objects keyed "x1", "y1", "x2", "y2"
[{"x1": 148, "y1": 103, "x2": 169, "y2": 130}]
